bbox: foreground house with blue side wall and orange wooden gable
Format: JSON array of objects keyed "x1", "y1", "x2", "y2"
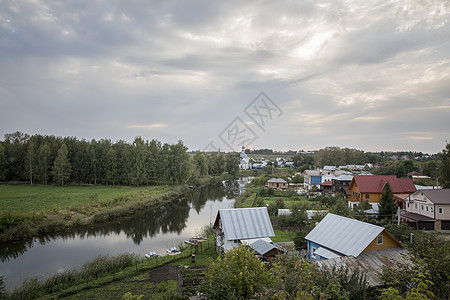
[{"x1": 305, "y1": 213, "x2": 401, "y2": 261}]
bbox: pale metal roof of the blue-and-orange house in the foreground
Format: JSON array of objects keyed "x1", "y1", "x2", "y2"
[{"x1": 305, "y1": 213, "x2": 384, "y2": 257}]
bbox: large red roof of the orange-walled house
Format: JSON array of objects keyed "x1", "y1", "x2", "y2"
[{"x1": 353, "y1": 175, "x2": 416, "y2": 194}]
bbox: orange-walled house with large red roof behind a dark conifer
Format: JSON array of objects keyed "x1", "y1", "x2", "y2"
[{"x1": 347, "y1": 175, "x2": 416, "y2": 210}]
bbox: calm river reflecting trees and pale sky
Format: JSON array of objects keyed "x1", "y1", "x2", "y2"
[{"x1": 0, "y1": 178, "x2": 248, "y2": 289}]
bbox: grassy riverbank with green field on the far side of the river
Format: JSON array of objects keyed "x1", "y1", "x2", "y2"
[{"x1": 0, "y1": 177, "x2": 222, "y2": 243}]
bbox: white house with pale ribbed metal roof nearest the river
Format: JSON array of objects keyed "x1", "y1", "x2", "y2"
[{"x1": 213, "y1": 207, "x2": 275, "y2": 253}]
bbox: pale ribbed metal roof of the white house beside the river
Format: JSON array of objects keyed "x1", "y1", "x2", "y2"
[{"x1": 219, "y1": 207, "x2": 275, "y2": 241}]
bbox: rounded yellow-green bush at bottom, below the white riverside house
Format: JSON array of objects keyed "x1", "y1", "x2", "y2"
[{"x1": 203, "y1": 247, "x2": 270, "y2": 299}]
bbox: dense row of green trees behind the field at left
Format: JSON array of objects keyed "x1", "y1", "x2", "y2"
[{"x1": 0, "y1": 132, "x2": 239, "y2": 186}]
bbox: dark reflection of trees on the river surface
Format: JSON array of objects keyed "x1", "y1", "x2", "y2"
[{"x1": 0, "y1": 181, "x2": 232, "y2": 262}]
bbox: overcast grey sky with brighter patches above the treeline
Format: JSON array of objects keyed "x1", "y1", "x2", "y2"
[{"x1": 0, "y1": 0, "x2": 450, "y2": 154}]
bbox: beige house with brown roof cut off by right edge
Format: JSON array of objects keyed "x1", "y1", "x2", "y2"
[{"x1": 400, "y1": 189, "x2": 450, "y2": 230}]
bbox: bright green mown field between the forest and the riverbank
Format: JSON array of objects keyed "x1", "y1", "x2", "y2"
[{"x1": 0, "y1": 185, "x2": 170, "y2": 213}]
